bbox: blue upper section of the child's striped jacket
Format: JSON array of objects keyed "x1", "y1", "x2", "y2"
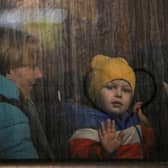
[{"x1": 64, "y1": 103, "x2": 139, "y2": 133}]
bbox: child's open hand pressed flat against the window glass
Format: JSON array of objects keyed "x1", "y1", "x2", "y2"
[{"x1": 98, "y1": 119, "x2": 124, "y2": 153}]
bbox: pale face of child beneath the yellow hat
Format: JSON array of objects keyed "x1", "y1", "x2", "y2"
[{"x1": 96, "y1": 80, "x2": 133, "y2": 114}]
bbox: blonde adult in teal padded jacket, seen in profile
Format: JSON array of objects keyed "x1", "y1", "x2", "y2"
[{"x1": 0, "y1": 28, "x2": 53, "y2": 159}]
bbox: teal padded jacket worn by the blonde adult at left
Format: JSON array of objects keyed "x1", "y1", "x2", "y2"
[{"x1": 0, "y1": 75, "x2": 38, "y2": 160}]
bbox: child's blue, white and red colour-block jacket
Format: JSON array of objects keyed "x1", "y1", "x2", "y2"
[{"x1": 64, "y1": 103, "x2": 153, "y2": 159}]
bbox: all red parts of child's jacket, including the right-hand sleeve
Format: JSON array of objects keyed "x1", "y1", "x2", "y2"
[{"x1": 69, "y1": 126, "x2": 153, "y2": 160}]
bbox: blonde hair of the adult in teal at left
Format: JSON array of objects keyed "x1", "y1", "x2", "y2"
[{"x1": 0, "y1": 28, "x2": 41, "y2": 75}]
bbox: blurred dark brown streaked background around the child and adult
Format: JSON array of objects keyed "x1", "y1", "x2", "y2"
[{"x1": 0, "y1": 0, "x2": 168, "y2": 161}]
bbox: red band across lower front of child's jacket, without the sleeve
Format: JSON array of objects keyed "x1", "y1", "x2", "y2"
[{"x1": 69, "y1": 139, "x2": 143, "y2": 159}]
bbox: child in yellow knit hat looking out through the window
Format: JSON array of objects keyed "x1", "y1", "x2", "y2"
[{"x1": 69, "y1": 55, "x2": 153, "y2": 160}]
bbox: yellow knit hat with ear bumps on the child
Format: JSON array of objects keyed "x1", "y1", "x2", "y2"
[{"x1": 88, "y1": 55, "x2": 136, "y2": 101}]
